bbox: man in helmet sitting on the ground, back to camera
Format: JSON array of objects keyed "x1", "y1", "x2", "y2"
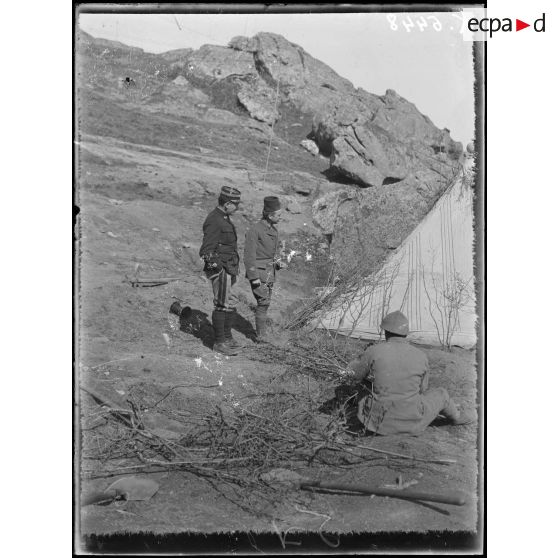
[{"x1": 347, "y1": 311, "x2": 473, "y2": 435}]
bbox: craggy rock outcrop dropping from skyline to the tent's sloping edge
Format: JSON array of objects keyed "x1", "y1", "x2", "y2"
[{"x1": 221, "y1": 34, "x2": 462, "y2": 262}]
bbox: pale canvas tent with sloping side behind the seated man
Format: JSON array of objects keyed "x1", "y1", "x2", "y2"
[{"x1": 315, "y1": 161, "x2": 476, "y2": 347}]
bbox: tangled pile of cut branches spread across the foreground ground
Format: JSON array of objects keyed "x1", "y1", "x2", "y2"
[{"x1": 82, "y1": 382, "x2": 460, "y2": 483}]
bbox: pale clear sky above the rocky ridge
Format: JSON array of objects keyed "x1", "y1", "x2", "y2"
[{"x1": 78, "y1": 13, "x2": 480, "y2": 146}]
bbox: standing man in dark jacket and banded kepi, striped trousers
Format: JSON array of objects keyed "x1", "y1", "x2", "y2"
[{"x1": 200, "y1": 186, "x2": 244, "y2": 355}]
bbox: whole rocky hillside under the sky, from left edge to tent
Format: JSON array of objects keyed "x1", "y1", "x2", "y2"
[{"x1": 77, "y1": 33, "x2": 462, "y2": 274}]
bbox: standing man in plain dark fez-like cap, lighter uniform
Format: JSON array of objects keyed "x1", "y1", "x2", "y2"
[{"x1": 244, "y1": 196, "x2": 287, "y2": 342}]
